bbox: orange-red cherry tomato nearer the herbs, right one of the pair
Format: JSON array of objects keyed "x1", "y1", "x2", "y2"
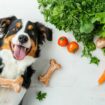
[{"x1": 67, "y1": 41, "x2": 79, "y2": 53}]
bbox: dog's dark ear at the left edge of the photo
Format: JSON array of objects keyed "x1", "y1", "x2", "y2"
[{"x1": 0, "y1": 16, "x2": 16, "y2": 38}]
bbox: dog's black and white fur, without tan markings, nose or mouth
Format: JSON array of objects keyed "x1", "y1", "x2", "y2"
[{"x1": 0, "y1": 16, "x2": 52, "y2": 105}]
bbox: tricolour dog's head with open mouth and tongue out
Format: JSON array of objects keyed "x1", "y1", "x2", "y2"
[{"x1": 2, "y1": 18, "x2": 52, "y2": 60}]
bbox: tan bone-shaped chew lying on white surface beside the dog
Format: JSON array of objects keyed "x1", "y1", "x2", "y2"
[{"x1": 38, "y1": 59, "x2": 61, "y2": 86}]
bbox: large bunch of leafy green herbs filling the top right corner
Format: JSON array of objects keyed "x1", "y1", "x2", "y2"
[{"x1": 38, "y1": 0, "x2": 105, "y2": 64}]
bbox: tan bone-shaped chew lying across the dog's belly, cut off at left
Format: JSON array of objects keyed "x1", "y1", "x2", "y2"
[{"x1": 0, "y1": 77, "x2": 23, "y2": 93}]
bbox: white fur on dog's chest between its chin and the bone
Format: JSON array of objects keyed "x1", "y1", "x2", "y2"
[{"x1": 0, "y1": 49, "x2": 35, "y2": 79}]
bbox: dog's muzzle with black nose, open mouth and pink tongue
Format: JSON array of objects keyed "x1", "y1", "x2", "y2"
[{"x1": 11, "y1": 35, "x2": 31, "y2": 60}]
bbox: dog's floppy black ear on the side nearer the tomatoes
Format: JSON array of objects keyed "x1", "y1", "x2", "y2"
[{"x1": 34, "y1": 22, "x2": 52, "y2": 44}]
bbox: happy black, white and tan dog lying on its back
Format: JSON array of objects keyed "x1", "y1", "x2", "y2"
[{"x1": 0, "y1": 16, "x2": 52, "y2": 105}]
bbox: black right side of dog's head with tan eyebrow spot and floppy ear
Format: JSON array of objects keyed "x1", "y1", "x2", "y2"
[{"x1": 25, "y1": 21, "x2": 52, "y2": 44}]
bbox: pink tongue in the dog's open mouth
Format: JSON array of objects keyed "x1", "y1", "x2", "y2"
[{"x1": 13, "y1": 45, "x2": 26, "y2": 60}]
